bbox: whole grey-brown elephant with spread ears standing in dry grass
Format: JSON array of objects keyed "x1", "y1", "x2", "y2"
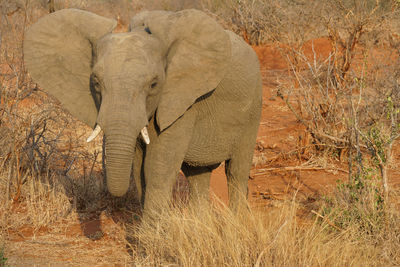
[{"x1": 24, "y1": 9, "x2": 262, "y2": 217}]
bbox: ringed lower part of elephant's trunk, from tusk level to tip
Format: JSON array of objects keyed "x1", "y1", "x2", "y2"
[{"x1": 106, "y1": 126, "x2": 140, "y2": 197}]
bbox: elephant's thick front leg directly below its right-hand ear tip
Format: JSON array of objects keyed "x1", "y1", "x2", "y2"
[{"x1": 143, "y1": 112, "x2": 195, "y2": 220}]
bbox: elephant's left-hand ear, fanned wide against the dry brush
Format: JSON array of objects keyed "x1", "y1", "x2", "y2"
[{"x1": 24, "y1": 9, "x2": 116, "y2": 126}]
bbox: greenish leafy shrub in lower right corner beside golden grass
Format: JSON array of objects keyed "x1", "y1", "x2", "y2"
[{"x1": 320, "y1": 183, "x2": 400, "y2": 266}]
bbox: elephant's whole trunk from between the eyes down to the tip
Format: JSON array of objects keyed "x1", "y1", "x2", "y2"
[{"x1": 97, "y1": 86, "x2": 148, "y2": 197}]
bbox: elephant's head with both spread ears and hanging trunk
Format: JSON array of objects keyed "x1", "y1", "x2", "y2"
[{"x1": 24, "y1": 9, "x2": 231, "y2": 196}]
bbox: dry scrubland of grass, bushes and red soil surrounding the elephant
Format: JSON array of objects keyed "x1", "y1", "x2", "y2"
[{"x1": 0, "y1": 0, "x2": 400, "y2": 266}]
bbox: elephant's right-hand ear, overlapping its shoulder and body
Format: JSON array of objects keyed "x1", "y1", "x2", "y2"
[{"x1": 131, "y1": 10, "x2": 231, "y2": 130}]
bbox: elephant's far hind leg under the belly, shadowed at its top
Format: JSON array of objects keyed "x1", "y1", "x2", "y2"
[{"x1": 182, "y1": 163, "x2": 215, "y2": 205}]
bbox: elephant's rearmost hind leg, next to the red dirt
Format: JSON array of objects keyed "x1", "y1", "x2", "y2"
[{"x1": 225, "y1": 125, "x2": 258, "y2": 211}]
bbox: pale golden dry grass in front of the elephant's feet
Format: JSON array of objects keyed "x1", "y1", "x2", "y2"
[{"x1": 133, "y1": 198, "x2": 400, "y2": 266}]
